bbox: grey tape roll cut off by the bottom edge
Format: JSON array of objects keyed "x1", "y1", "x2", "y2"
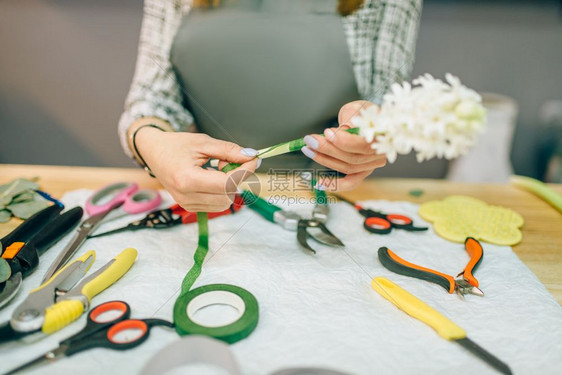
[{"x1": 140, "y1": 335, "x2": 240, "y2": 375}]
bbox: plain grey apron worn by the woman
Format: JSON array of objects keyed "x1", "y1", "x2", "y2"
[{"x1": 170, "y1": 0, "x2": 359, "y2": 169}]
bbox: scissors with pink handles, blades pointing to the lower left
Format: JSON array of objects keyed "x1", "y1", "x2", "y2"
[{"x1": 41, "y1": 182, "x2": 162, "y2": 284}]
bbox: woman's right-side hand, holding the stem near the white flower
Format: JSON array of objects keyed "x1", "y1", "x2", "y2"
[{"x1": 302, "y1": 100, "x2": 386, "y2": 191}]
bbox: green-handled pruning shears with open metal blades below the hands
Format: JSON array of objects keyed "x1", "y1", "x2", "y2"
[{"x1": 242, "y1": 190, "x2": 345, "y2": 254}]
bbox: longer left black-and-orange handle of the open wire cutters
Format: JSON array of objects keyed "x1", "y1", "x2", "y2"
[{"x1": 378, "y1": 246, "x2": 455, "y2": 293}]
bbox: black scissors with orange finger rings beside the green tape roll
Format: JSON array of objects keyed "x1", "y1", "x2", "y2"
[{"x1": 6, "y1": 301, "x2": 174, "y2": 375}]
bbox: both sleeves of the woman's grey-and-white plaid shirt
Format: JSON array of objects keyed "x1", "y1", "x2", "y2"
[{"x1": 119, "y1": 0, "x2": 422, "y2": 157}]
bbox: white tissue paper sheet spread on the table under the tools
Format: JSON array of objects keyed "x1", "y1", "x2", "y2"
[{"x1": 0, "y1": 190, "x2": 562, "y2": 375}]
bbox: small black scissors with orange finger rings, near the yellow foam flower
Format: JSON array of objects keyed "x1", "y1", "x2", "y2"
[{"x1": 334, "y1": 194, "x2": 427, "y2": 234}]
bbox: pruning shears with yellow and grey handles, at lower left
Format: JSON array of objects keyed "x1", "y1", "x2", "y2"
[{"x1": 0, "y1": 248, "x2": 137, "y2": 341}]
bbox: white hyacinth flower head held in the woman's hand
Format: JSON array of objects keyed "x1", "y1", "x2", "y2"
[{"x1": 351, "y1": 73, "x2": 486, "y2": 163}]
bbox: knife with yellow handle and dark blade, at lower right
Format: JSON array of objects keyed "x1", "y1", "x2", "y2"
[{"x1": 371, "y1": 277, "x2": 511, "y2": 374}]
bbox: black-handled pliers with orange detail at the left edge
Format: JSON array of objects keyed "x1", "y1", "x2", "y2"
[{"x1": 0, "y1": 205, "x2": 83, "y2": 308}]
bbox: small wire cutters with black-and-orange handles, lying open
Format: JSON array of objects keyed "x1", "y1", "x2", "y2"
[{"x1": 378, "y1": 237, "x2": 484, "y2": 299}]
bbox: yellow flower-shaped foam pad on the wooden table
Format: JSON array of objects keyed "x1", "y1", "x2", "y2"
[{"x1": 419, "y1": 195, "x2": 523, "y2": 245}]
